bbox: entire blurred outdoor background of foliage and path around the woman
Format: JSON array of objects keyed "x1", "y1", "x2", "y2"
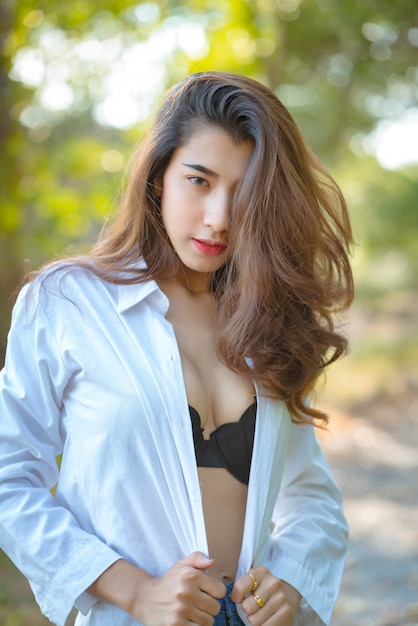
[{"x1": 0, "y1": 0, "x2": 418, "y2": 626}]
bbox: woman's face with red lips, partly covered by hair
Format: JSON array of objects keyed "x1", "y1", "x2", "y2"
[{"x1": 161, "y1": 126, "x2": 252, "y2": 289}]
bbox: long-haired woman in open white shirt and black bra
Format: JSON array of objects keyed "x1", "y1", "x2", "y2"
[{"x1": 0, "y1": 72, "x2": 353, "y2": 626}]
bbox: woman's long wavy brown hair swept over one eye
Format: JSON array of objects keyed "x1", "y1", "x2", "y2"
[{"x1": 33, "y1": 72, "x2": 353, "y2": 424}]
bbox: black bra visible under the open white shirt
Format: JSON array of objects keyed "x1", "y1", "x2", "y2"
[{"x1": 189, "y1": 401, "x2": 257, "y2": 485}]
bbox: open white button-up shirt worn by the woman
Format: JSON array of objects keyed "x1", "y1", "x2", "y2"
[{"x1": 0, "y1": 267, "x2": 347, "y2": 626}]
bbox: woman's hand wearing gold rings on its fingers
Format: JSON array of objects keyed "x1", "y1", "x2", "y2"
[{"x1": 231, "y1": 567, "x2": 301, "y2": 626}]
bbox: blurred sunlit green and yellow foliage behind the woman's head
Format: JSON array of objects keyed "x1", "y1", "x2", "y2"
[{"x1": 0, "y1": 0, "x2": 418, "y2": 360}]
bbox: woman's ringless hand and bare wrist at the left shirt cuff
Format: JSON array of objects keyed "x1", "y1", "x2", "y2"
[{"x1": 89, "y1": 552, "x2": 226, "y2": 626}]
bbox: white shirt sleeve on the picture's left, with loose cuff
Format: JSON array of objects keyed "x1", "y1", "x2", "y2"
[{"x1": 0, "y1": 283, "x2": 120, "y2": 626}]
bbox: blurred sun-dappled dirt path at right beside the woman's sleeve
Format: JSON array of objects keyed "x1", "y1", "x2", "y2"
[{"x1": 322, "y1": 391, "x2": 418, "y2": 626}]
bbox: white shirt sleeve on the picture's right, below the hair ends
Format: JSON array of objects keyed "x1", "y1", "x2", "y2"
[{"x1": 267, "y1": 416, "x2": 348, "y2": 626}]
